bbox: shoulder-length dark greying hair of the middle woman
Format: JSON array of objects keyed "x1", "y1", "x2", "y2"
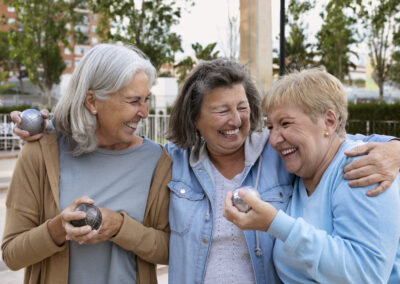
[{"x1": 167, "y1": 59, "x2": 262, "y2": 149}]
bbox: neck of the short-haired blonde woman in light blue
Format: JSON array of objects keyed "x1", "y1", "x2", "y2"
[{"x1": 303, "y1": 136, "x2": 344, "y2": 196}]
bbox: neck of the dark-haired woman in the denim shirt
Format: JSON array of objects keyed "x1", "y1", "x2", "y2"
[{"x1": 208, "y1": 145, "x2": 245, "y2": 179}]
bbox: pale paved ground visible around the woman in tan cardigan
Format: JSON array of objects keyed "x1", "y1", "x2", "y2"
[{"x1": 0, "y1": 151, "x2": 168, "y2": 284}]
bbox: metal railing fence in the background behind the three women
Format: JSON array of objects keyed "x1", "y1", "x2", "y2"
[{"x1": 0, "y1": 114, "x2": 400, "y2": 150}]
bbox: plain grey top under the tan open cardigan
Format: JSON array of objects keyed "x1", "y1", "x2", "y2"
[{"x1": 58, "y1": 136, "x2": 162, "y2": 284}]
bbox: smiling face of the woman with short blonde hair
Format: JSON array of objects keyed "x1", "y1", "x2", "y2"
[{"x1": 267, "y1": 104, "x2": 336, "y2": 179}]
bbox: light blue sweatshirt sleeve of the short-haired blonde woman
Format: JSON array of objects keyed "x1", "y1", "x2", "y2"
[{"x1": 268, "y1": 178, "x2": 400, "y2": 283}]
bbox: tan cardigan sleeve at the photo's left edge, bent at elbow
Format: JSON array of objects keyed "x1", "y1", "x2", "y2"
[{"x1": 1, "y1": 142, "x2": 65, "y2": 270}]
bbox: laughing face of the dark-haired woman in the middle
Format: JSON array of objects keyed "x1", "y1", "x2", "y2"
[{"x1": 195, "y1": 84, "x2": 250, "y2": 159}]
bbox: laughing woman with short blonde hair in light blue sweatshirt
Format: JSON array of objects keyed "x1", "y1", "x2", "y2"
[{"x1": 224, "y1": 69, "x2": 400, "y2": 283}]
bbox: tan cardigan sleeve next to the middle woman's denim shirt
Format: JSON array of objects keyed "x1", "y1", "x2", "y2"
[{"x1": 111, "y1": 150, "x2": 171, "y2": 264}]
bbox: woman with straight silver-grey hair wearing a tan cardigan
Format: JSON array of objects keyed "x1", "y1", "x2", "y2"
[{"x1": 1, "y1": 44, "x2": 171, "y2": 283}]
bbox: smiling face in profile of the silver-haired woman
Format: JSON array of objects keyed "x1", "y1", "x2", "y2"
[{"x1": 86, "y1": 71, "x2": 150, "y2": 150}]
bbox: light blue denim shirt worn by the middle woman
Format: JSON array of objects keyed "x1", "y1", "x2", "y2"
[{"x1": 165, "y1": 130, "x2": 391, "y2": 284}]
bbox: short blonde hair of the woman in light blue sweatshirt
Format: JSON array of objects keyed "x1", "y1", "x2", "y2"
[{"x1": 262, "y1": 68, "x2": 348, "y2": 137}]
